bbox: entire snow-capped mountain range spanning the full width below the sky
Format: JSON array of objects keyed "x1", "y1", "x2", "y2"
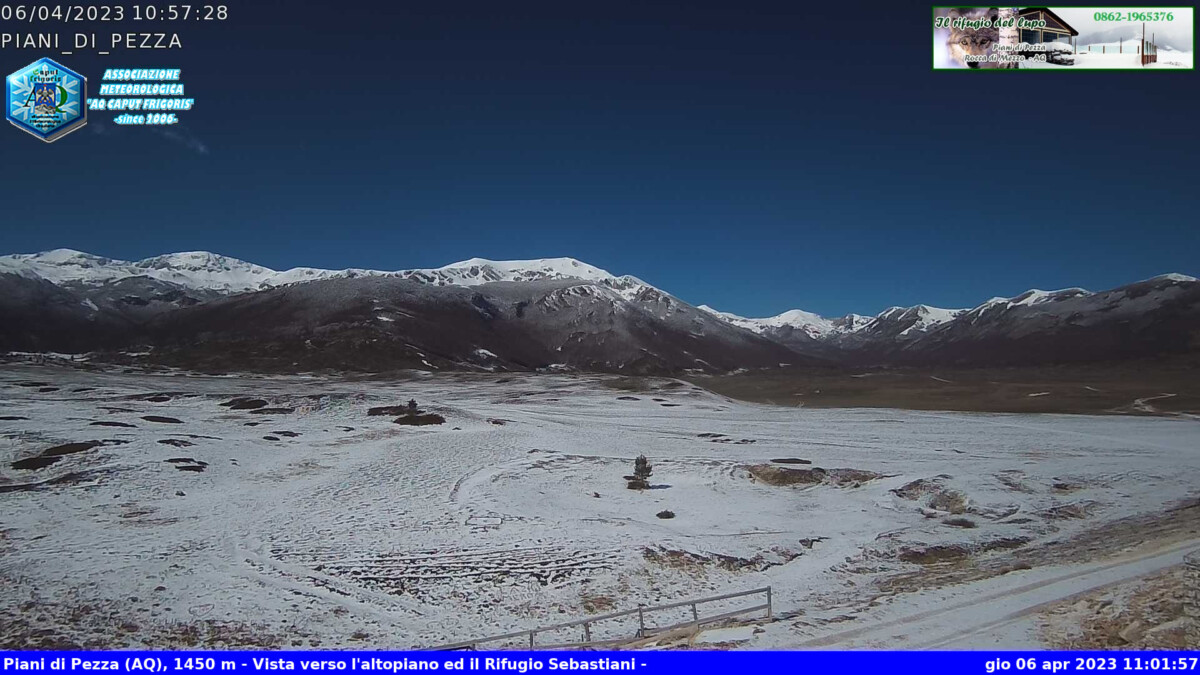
[{"x1": 0, "y1": 249, "x2": 1200, "y2": 372}]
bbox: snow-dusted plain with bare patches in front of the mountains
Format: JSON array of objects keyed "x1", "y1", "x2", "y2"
[{"x1": 0, "y1": 365, "x2": 1200, "y2": 649}]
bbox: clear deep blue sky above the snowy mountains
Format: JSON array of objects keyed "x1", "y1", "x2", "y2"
[{"x1": 0, "y1": 1, "x2": 1200, "y2": 316}]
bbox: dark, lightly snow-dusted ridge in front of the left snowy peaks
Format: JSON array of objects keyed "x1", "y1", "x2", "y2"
[{"x1": 145, "y1": 277, "x2": 798, "y2": 374}]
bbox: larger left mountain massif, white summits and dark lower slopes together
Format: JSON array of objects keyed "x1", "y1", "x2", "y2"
[{"x1": 0, "y1": 249, "x2": 805, "y2": 372}]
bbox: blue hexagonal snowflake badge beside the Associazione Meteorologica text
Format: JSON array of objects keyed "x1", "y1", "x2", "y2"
[{"x1": 5, "y1": 59, "x2": 88, "y2": 143}]
